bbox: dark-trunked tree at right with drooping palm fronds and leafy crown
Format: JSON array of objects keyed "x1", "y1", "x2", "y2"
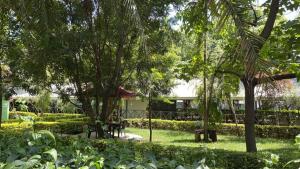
[{"x1": 216, "y1": 0, "x2": 299, "y2": 152}]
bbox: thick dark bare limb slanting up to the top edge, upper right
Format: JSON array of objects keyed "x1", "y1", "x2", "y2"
[{"x1": 260, "y1": 0, "x2": 280, "y2": 39}]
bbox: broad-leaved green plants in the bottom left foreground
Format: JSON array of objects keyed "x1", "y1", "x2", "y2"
[{"x1": 0, "y1": 131, "x2": 211, "y2": 169}]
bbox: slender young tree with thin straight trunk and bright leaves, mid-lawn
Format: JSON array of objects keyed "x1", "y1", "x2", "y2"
[{"x1": 137, "y1": 43, "x2": 180, "y2": 142}]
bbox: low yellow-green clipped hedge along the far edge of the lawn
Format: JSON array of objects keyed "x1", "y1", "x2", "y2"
[{"x1": 127, "y1": 119, "x2": 300, "y2": 139}]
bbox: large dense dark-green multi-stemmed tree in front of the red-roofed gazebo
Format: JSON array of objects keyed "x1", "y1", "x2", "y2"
[{"x1": 10, "y1": 0, "x2": 184, "y2": 128}]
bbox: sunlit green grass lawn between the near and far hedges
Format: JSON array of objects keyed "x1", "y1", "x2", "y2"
[{"x1": 125, "y1": 128, "x2": 300, "y2": 158}]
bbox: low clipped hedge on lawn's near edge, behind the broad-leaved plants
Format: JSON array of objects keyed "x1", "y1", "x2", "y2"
[{"x1": 92, "y1": 140, "x2": 299, "y2": 169}]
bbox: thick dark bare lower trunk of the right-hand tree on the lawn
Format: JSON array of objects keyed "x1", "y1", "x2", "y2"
[{"x1": 243, "y1": 80, "x2": 257, "y2": 152}]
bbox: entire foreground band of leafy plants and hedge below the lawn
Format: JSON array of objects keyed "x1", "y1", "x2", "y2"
[{"x1": 0, "y1": 131, "x2": 294, "y2": 169}]
